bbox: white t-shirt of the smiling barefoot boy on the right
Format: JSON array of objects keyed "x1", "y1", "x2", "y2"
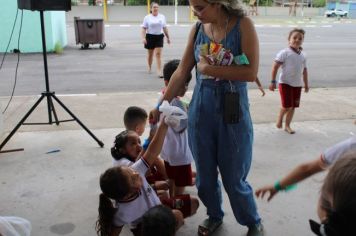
[{"x1": 275, "y1": 47, "x2": 307, "y2": 87}]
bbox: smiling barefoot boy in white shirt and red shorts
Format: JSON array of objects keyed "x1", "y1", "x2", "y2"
[{"x1": 269, "y1": 28, "x2": 309, "y2": 134}]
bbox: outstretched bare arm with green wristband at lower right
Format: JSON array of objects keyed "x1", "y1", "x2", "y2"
[{"x1": 255, "y1": 157, "x2": 325, "y2": 201}]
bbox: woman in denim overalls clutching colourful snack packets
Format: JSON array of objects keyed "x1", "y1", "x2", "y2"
[{"x1": 151, "y1": 0, "x2": 263, "y2": 236}]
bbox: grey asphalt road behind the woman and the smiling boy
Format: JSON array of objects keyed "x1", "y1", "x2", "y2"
[{"x1": 0, "y1": 20, "x2": 356, "y2": 96}]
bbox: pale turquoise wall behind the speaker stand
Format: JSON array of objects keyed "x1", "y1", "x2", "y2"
[{"x1": 0, "y1": 0, "x2": 67, "y2": 52}]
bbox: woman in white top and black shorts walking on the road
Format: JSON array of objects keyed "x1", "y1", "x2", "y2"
[{"x1": 141, "y1": 2, "x2": 171, "y2": 78}]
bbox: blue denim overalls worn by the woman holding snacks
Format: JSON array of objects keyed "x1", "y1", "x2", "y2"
[{"x1": 188, "y1": 20, "x2": 260, "y2": 226}]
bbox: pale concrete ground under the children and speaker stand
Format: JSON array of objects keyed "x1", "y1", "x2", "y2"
[{"x1": 0, "y1": 87, "x2": 356, "y2": 236}]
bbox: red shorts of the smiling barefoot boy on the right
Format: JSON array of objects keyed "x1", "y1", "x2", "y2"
[{"x1": 278, "y1": 84, "x2": 302, "y2": 108}]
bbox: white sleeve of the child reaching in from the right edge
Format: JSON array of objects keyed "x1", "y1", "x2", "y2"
[{"x1": 321, "y1": 136, "x2": 356, "y2": 166}]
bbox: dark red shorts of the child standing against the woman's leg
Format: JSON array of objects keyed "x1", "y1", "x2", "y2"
[{"x1": 164, "y1": 161, "x2": 193, "y2": 187}]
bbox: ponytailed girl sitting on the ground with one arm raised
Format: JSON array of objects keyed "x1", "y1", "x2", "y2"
[{"x1": 96, "y1": 122, "x2": 199, "y2": 235}]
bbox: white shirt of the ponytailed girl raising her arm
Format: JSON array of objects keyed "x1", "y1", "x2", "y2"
[{"x1": 113, "y1": 158, "x2": 161, "y2": 228}]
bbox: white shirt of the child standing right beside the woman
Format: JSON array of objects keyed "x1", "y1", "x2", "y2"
[{"x1": 160, "y1": 98, "x2": 193, "y2": 166}]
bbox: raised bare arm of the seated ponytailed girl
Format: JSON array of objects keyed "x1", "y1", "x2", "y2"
[{"x1": 143, "y1": 122, "x2": 168, "y2": 166}]
